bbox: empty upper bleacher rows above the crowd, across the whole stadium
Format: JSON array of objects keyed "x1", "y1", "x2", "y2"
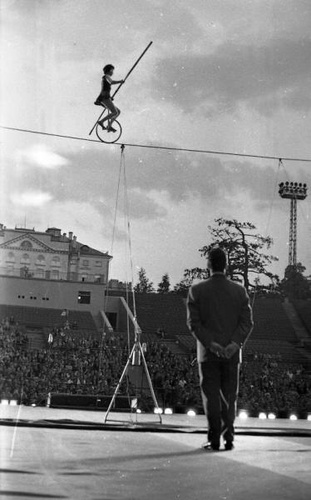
[{"x1": 0, "y1": 293, "x2": 311, "y2": 362}]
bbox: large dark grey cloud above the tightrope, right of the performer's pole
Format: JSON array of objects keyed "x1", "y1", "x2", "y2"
[{"x1": 155, "y1": 38, "x2": 311, "y2": 116}]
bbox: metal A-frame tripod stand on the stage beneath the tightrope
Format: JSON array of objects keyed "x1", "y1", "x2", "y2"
[{"x1": 104, "y1": 320, "x2": 162, "y2": 424}]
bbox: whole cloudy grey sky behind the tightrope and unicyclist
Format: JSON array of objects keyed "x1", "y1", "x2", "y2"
[{"x1": 0, "y1": 0, "x2": 311, "y2": 284}]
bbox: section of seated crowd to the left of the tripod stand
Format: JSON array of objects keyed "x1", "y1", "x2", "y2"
[{"x1": 0, "y1": 325, "x2": 127, "y2": 405}]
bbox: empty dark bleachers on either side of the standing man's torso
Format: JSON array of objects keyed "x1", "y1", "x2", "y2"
[{"x1": 136, "y1": 293, "x2": 311, "y2": 365}]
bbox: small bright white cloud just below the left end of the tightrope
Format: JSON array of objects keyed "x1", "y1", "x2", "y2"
[{"x1": 16, "y1": 144, "x2": 68, "y2": 170}]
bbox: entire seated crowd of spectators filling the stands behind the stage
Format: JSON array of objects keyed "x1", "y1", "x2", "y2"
[{"x1": 0, "y1": 318, "x2": 311, "y2": 413}]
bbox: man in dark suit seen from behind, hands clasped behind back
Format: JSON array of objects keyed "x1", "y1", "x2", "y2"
[{"x1": 187, "y1": 247, "x2": 253, "y2": 451}]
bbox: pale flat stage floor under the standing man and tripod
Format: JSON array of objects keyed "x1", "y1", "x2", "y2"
[{"x1": 0, "y1": 405, "x2": 311, "y2": 500}]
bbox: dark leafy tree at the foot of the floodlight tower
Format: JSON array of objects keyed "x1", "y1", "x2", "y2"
[{"x1": 279, "y1": 262, "x2": 311, "y2": 299}]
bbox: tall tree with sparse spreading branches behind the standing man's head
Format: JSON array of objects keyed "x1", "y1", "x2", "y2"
[{"x1": 175, "y1": 218, "x2": 278, "y2": 293}]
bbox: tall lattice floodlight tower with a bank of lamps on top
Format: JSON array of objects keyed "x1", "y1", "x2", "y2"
[{"x1": 279, "y1": 182, "x2": 308, "y2": 266}]
